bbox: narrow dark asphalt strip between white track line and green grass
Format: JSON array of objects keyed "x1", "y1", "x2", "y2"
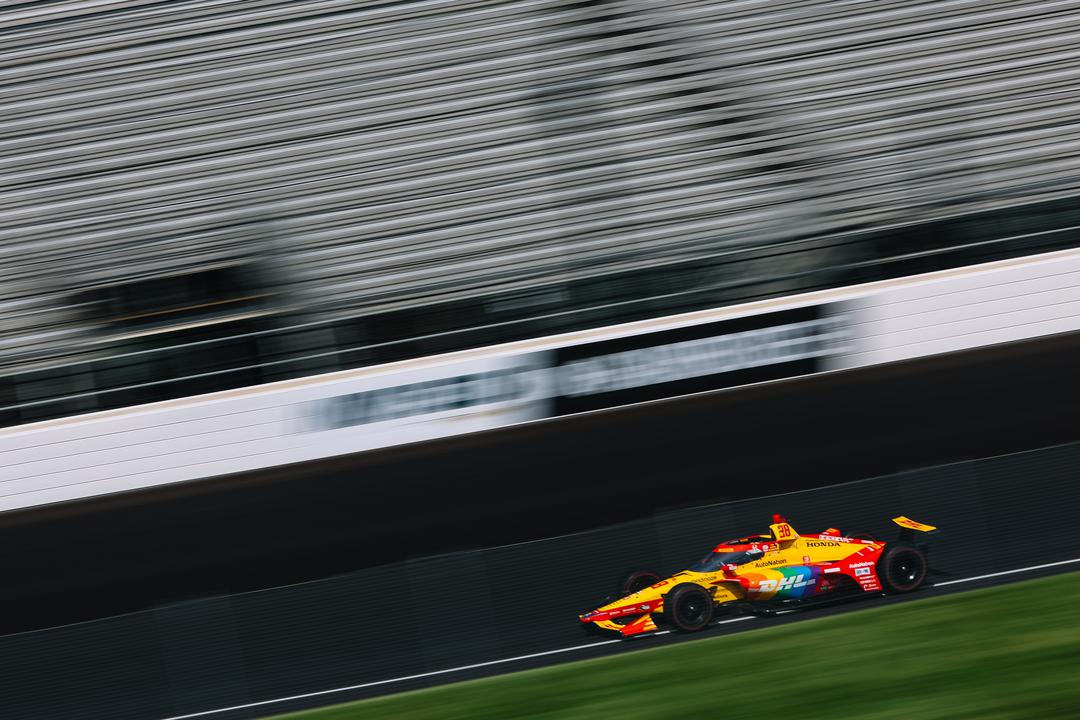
[{"x1": 157, "y1": 546, "x2": 1080, "y2": 720}]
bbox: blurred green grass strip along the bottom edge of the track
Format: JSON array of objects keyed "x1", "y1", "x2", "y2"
[{"x1": 267, "y1": 572, "x2": 1080, "y2": 720}]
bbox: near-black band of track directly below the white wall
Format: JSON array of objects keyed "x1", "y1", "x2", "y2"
[{"x1": 0, "y1": 335, "x2": 1080, "y2": 634}]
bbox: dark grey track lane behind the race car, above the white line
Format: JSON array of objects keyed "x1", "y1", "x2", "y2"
[{"x1": 0, "y1": 444, "x2": 1080, "y2": 720}]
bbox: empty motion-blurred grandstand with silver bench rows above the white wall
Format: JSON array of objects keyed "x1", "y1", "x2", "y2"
[{"x1": 0, "y1": 0, "x2": 1080, "y2": 425}]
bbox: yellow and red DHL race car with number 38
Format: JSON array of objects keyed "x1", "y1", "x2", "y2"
[{"x1": 579, "y1": 515, "x2": 937, "y2": 637}]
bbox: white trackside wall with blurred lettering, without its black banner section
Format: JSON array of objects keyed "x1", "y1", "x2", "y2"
[{"x1": 0, "y1": 250, "x2": 1080, "y2": 511}]
